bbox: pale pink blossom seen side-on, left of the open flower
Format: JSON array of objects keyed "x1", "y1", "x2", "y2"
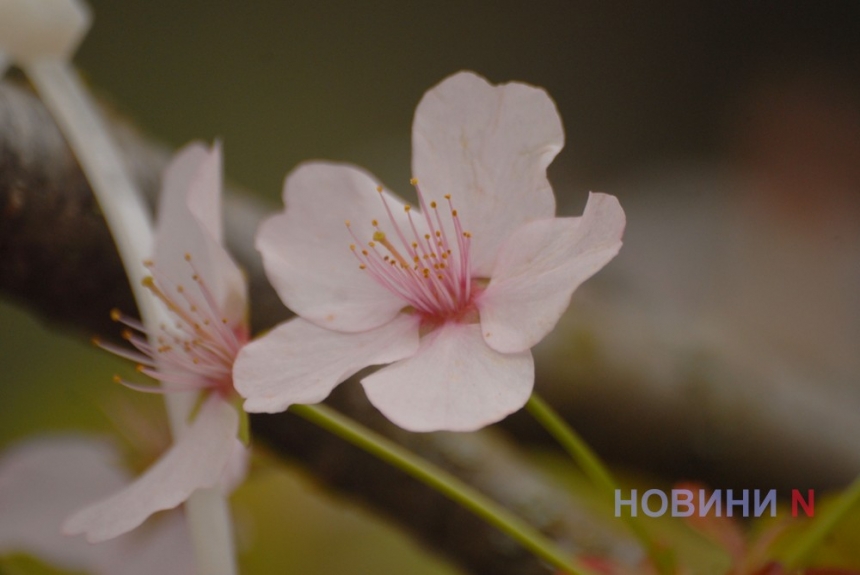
[{"x1": 63, "y1": 144, "x2": 248, "y2": 542}]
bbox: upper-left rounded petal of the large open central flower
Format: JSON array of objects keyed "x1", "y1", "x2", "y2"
[{"x1": 257, "y1": 162, "x2": 408, "y2": 332}]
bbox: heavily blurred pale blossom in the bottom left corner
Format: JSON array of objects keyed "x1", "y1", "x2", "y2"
[{"x1": 0, "y1": 435, "x2": 194, "y2": 575}]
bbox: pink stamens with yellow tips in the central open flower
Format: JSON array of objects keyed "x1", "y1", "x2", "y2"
[{"x1": 346, "y1": 178, "x2": 473, "y2": 320}]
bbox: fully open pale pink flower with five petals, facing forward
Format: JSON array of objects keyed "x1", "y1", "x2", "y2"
[{"x1": 234, "y1": 72, "x2": 625, "y2": 431}]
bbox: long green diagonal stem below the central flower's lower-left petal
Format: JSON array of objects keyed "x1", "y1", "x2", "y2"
[{"x1": 290, "y1": 405, "x2": 594, "y2": 575}]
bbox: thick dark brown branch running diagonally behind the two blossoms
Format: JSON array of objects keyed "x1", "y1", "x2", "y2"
[{"x1": 0, "y1": 82, "x2": 630, "y2": 575}]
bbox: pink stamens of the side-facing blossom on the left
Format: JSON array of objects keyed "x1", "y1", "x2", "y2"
[{"x1": 96, "y1": 254, "x2": 249, "y2": 397}]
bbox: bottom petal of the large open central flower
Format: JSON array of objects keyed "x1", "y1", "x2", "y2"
[{"x1": 361, "y1": 323, "x2": 534, "y2": 431}]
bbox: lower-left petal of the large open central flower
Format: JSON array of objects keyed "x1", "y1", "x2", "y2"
[{"x1": 233, "y1": 314, "x2": 419, "y2": 413}]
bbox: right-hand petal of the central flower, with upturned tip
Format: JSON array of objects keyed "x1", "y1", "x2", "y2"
[{"x1": 478, "y1": 194, "x2": 625, "y2": 353}]
